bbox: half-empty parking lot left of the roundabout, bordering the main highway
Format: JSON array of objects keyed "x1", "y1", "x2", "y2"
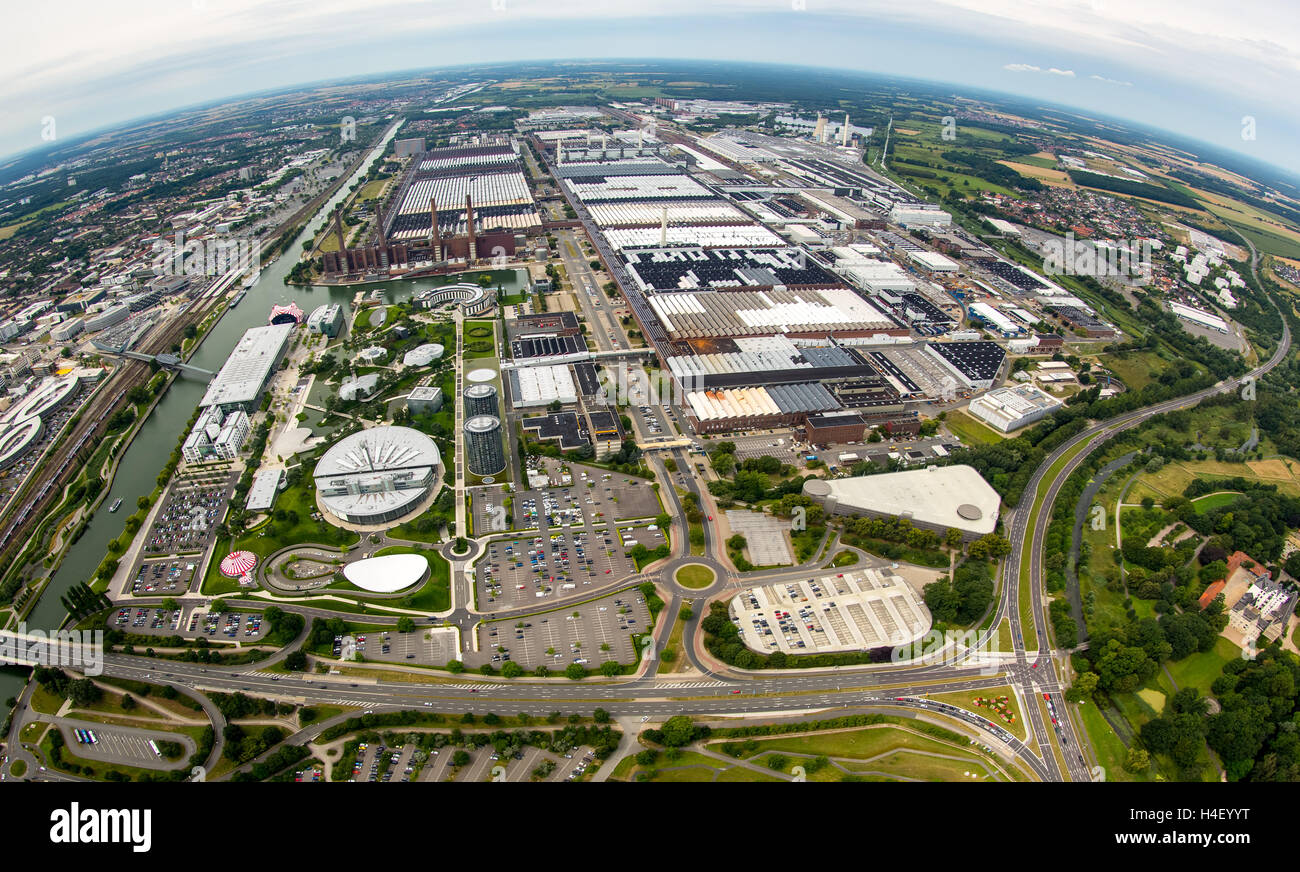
[{"x1": 465, "y1": 587, "x2": 651, "y2": 672}]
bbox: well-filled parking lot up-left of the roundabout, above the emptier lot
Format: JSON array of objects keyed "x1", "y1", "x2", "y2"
[{"x1": 475, "y1": 524, "x2": 666, "y2": 611}]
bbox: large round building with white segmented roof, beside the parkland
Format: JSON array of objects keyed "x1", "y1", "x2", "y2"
[{"x1": 312, "y1": 426, "x2": 441, "y2": 524}]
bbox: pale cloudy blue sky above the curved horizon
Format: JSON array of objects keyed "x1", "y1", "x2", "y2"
[{"x1": 10, "y1": 0, "x2": 1300, "y2": 172}]
